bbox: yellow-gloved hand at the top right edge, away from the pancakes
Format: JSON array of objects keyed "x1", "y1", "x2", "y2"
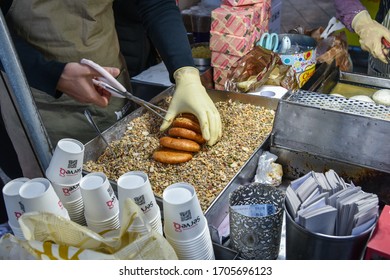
[{"x1": 351, "y1": 10, "x2": 390, "y2": 64}]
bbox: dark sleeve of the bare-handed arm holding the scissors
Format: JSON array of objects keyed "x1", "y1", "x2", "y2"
[{"x1": 0, "y1": 0, "x2": 66, "y2": 98}]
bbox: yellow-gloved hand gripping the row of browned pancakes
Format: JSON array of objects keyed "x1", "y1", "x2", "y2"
[{"x1": 160, "y1": 66, "x2": 222, "y2": 146}]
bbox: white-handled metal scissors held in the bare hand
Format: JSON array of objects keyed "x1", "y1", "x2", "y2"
[{"x1": 80, "y1": 58, "x2": 167, "y2": 120}]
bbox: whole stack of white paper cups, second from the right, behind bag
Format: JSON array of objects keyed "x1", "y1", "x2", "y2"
[{"x1": 117, "y1": 171, "x2": 163, "y2": 235}]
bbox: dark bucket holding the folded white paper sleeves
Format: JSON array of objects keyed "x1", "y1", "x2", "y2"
[{"x1": 284, "y1": 201, "x2": 375, "y2": 260}]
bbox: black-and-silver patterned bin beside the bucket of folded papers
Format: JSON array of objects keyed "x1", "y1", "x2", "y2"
[{"x1": 229, "y1": 183, "x2": 284, "y2": 260}]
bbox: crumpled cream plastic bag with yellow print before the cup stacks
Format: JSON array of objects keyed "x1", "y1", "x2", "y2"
[{"x1": 0, "y1": 199, "x2": 177, "y2": 260}]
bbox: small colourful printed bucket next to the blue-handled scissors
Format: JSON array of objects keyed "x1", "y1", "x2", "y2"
[{"x1": 278, "y1": 34, "x2": 317, "y2": 88}]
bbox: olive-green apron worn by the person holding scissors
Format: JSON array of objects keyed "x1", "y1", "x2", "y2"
[{"x1": 6, "y1": 0, "x2": 130, "y2": 146}]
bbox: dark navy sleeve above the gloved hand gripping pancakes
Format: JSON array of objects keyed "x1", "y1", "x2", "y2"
[{"x1": 137, "y1": 0, "x2": 194, "y2": 82}]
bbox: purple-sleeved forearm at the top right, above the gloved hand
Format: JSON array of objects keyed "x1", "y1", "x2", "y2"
[{"x1": 334, "y1": 0, "x2": 366, "y2": 32}]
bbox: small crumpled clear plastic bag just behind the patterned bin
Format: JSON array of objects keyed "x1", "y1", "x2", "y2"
[{"x1": 254, "y1": 151, "x2": 283, "y2": 187}]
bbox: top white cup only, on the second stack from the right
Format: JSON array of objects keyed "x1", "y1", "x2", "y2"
[{"x1": 117, "y1": 171, "x2": 160, "y2": 221}]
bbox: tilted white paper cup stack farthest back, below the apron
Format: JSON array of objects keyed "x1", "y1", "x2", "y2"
[{"x1": 46, "y1": 138, "x2": 86, "y2": 225}]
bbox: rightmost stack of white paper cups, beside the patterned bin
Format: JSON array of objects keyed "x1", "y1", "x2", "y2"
[{"x1": 163, "y1": 183, "x2": 215, "y2": 260}]
